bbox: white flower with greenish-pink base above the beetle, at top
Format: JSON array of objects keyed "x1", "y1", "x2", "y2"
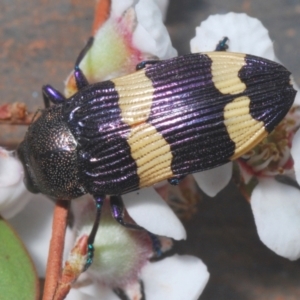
[{"x1": 65, "y1": 0, "x2": 177, "y2": 97}]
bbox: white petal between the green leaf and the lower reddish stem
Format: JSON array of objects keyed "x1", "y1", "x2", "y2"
[{"x1": 10, "y1": 194, "x2": 54, "y2": 277}]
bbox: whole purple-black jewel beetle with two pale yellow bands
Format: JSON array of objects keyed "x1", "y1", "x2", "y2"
[{"x1": 17, "y1": 39, "x2": 296, "y2": 266}]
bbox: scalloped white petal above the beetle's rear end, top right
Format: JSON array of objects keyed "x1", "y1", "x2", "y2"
[{"x1": 191, "y1": 12, "x2": 275, "y2": 60}]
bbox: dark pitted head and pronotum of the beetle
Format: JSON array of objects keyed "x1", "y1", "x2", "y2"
[{"x1": 17, "y1": 105, "x2": 85, "y2": 200}]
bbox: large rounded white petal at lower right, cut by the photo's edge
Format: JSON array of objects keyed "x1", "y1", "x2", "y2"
[{"x1": 251, "y1": 179, "x2": 300, "y2": 260}]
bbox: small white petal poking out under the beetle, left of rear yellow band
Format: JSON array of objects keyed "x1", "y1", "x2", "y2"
[{"x1": 193, "y1": 162, "x2": 232, "y2": 197}]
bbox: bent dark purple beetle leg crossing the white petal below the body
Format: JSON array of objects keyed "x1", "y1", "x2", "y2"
[{"x1": 110, "y1": 196, "x2": 162, "y2": 257}]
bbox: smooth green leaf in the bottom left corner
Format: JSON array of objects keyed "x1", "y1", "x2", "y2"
[{"x1": 0, "y1": 217, "x2": 39, "y2": 300}]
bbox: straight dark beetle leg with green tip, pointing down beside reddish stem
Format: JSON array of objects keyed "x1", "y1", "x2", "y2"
[{"x1": 84, "y1": 196, "x2": 105, "y2": 270}]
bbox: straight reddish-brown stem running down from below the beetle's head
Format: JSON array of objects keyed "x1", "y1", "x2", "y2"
[{"x1": 43, "y1": 200, "x2": 69, "y2": 300}]
